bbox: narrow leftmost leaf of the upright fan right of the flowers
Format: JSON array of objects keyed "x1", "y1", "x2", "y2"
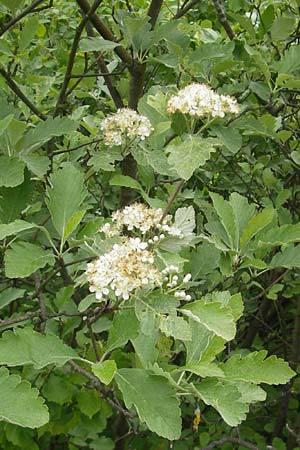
[{"x1": 210, "y1": 192, "x2": 238, "y2": 250}]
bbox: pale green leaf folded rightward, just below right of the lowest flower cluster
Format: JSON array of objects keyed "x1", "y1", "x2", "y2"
[{"x1": 180, "y1": 300, "x2": 236, "y2": 341}]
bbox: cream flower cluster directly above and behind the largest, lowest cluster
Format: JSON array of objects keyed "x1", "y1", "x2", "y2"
[{"x1": 100, "y1": 203, "x2": 183, "y2": 239}]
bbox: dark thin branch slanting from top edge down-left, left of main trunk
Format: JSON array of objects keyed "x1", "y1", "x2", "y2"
[{"x1": 53, "y1": 0, "x2": 102, "y2": 117}]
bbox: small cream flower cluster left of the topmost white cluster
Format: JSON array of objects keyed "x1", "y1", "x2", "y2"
[{"x1": 100, "y1": 108, "x2": 153, "y2": 145}]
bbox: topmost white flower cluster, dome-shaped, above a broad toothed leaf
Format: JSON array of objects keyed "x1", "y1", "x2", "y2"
[{"x1": 167, "y1": 83, "x2": 239, "y2": 117}]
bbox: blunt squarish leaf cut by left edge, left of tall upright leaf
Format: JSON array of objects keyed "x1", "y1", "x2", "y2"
[{"x1": 0, "y1": 155, "x2": 25, "y2": 187}]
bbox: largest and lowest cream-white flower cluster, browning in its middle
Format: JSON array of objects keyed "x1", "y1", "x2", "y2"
[{"x1": 86, "y1": 237, "x2": 162, "y2": 300}]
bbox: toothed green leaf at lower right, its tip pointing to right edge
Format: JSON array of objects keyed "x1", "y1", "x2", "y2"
[{"x1": 219, "y1": 350, "x2": 295, "y2": 384}]
